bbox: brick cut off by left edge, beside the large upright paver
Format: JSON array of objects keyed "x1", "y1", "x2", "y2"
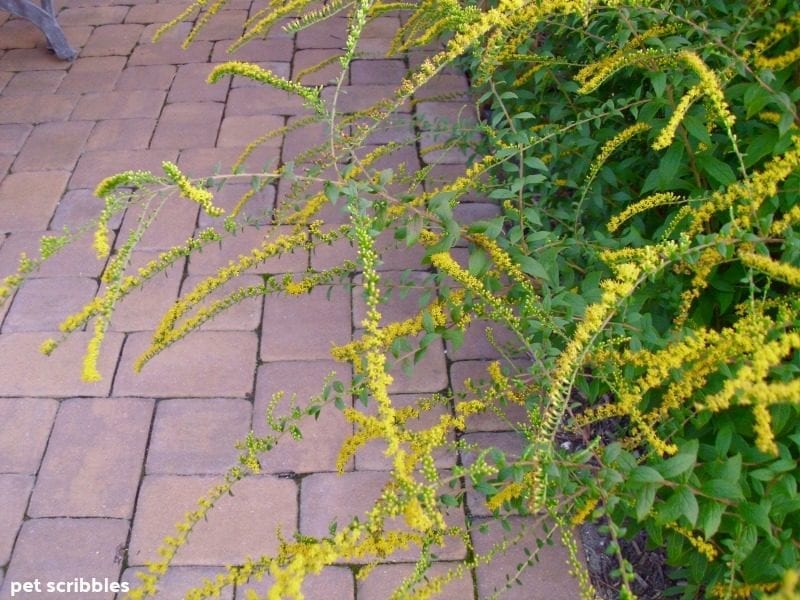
[{"x1": 0, "y1": 398, "x2": 58, "y2": 474}]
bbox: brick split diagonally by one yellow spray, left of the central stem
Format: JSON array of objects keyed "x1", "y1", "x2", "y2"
[{"x1": 189, "y1": 226, "x2": 308, "y2": 275}]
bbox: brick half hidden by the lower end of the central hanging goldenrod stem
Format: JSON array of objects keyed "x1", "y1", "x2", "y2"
[{"x1": 300, "y1": 471, "x2": 466, "y2": 562}]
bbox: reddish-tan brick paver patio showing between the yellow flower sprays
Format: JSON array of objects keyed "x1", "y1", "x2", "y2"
[{"x1": 0, "y1": 0, "x2": 578, "y2": 600}]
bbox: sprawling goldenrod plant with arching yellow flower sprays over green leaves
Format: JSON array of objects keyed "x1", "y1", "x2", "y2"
[{"x1": 0, "y1": 0, "x2": 800, "y2": 599}]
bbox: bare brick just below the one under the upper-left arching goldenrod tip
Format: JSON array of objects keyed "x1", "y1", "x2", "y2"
[{"x1": 150, "y1": 102, "x2": 223, "y2": 149}]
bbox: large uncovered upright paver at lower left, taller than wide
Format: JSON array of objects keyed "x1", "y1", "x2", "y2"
[{"x1": 28, "y1": 398, "x2": 153, "y2": 519}]
